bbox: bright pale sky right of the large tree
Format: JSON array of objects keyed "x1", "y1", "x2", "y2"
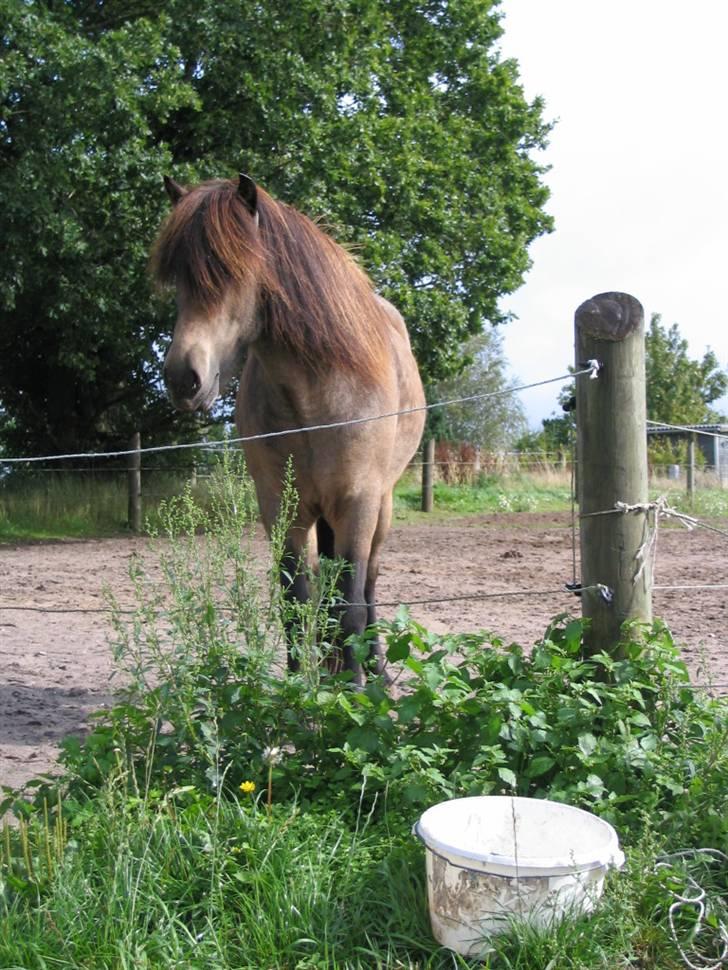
[{"x1": 500, "y1": 0, "x2": 728, "y2": 428}]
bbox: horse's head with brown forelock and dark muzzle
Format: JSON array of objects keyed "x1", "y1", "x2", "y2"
[{"x1": 152, "y1": 175, "x2": 260, "y2": 411}]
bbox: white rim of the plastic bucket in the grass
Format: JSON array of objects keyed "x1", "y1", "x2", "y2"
[{"x1": 412, "y1": 795, "x2": 625, "y2": 877}]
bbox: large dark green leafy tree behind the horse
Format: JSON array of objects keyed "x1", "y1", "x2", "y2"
[{"x1": 0, "y1": 0, "x2": 551, "y2": 456}]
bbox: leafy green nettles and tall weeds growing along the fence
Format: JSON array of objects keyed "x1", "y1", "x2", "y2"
[{"x1": 32, "y1": 455, "x2": 728, "y2": 845}]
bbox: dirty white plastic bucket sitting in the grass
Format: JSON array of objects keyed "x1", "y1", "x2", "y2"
[{"x1": 413, "y1": 795, "x2": 624, "y2": 956}]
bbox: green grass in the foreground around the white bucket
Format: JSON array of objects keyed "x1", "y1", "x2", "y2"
[{"x1": 0, "y1": 784, "x2": 716, "y2": 970}]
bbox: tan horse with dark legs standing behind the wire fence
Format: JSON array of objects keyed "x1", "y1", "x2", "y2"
[{"x1": 151, "y1": 175, "x2": 425, "y2": 686}]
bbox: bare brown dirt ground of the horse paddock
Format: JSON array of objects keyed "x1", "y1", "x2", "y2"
[{"x1": 0, "y1": 514, "x2": 728, "y2": 786}]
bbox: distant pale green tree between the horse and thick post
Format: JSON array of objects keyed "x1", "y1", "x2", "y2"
[{"x1": 431, "y1": 330, "x2": 526, "y2": 451}]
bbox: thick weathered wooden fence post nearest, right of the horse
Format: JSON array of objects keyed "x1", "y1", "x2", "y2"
[{"x1": 574, "y1": 293, "x2": 657, "y2": 654}]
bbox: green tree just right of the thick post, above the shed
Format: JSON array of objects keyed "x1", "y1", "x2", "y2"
[{"x1": 645, "y1": 313, "x2": 728, "y2": 424}]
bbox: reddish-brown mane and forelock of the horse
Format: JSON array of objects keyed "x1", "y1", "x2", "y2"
[{"x1": 151, "y1": 180, "x2": 389, "y2": 382}]
